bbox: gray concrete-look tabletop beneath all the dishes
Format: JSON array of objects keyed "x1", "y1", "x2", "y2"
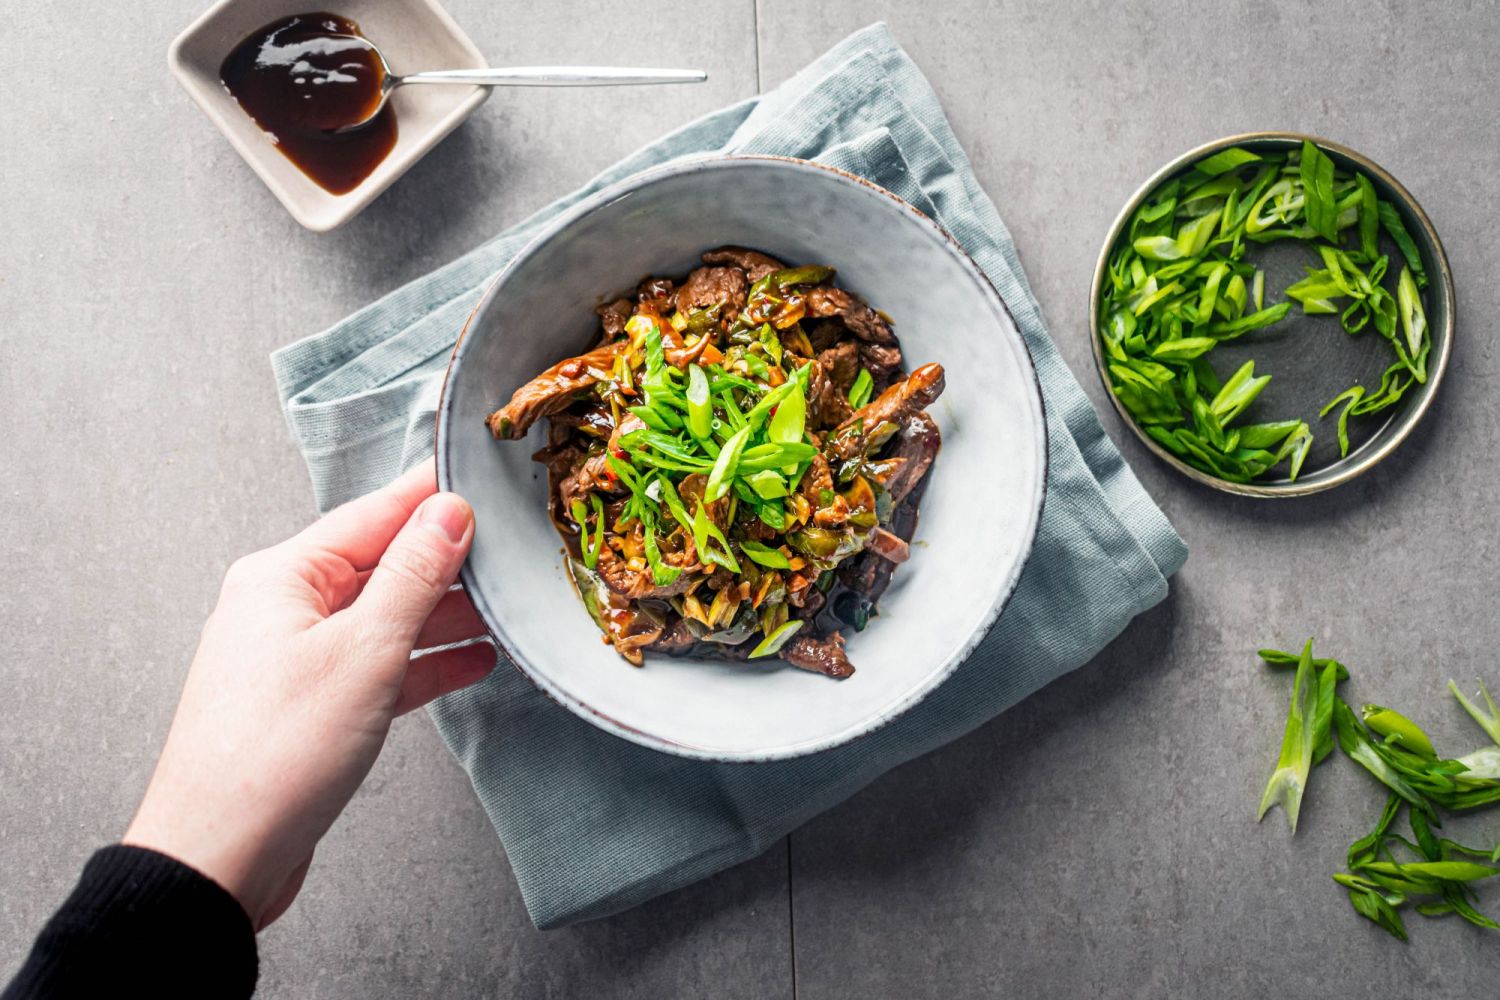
[{"x1": 0, "y1": 0, "x2": 1500, "y2": 1000}]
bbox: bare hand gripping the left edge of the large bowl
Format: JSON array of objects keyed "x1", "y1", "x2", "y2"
[{"x1": 123, "y1": 462, "x2": 495, "y2": 931}]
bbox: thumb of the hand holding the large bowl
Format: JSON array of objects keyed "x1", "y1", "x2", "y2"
[{"x1": 354, "y1": 493, "x2": 474, "y2": 651}]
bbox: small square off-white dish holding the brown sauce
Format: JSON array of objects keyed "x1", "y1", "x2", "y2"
[{"x1": 167, "y1": 0, "x2": 489, "y2": 232}]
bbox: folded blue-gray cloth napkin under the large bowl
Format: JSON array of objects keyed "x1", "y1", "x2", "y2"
[{"x1": 272, "y1": 24, "x2": 1187, "y2": 928}]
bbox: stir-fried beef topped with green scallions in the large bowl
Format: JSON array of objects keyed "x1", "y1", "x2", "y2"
[{"x1": 488, "y1": 246, "x2": 944, "y2": 678}]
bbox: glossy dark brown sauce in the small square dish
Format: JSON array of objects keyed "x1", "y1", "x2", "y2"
[{"x1": 219, "y1": 13, "x2": 396, "y2": 195}]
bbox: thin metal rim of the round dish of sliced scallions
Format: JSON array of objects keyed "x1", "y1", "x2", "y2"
[{"x1": 1089, "y1": 130, "x2": 1457, "y2": 499}]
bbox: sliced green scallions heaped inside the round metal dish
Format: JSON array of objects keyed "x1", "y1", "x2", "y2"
[{"x1": 1100, "y1": 142, "x2": 1431, "y2": 483}]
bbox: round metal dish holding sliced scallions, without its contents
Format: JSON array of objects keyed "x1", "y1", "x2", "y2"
[{"x1": 1089, "y1": 132, "x2": 1454, "y2": 498}]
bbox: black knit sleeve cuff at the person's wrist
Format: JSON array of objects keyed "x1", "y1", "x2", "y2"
[{"x1": 0, "y1": 844, "x2": 258, "y2": 1000}]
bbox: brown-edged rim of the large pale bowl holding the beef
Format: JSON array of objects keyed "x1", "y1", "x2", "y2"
[{"x1": 434, "y1": 153, "x2": 1050, "y2": 763}]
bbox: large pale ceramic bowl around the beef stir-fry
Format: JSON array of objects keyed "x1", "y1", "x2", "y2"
[{"x1": 437, "y1": 157, "x2": 1047, "y2": 762}]
